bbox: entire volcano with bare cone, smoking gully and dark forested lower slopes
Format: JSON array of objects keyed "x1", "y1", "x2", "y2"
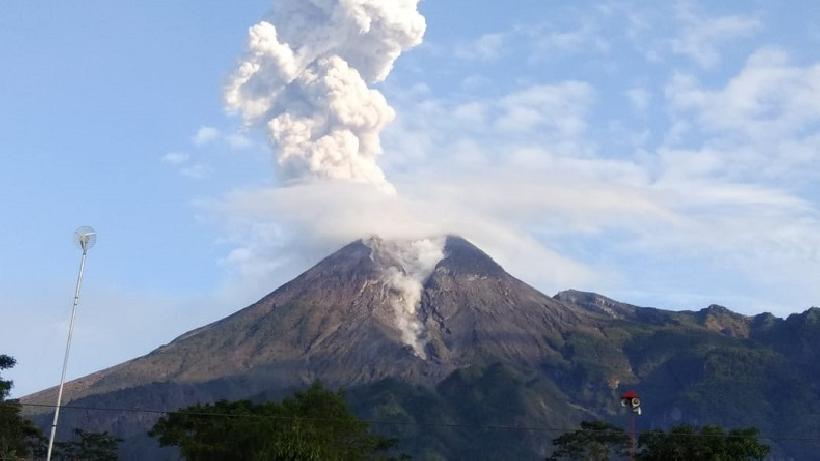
[{"x1": 23, "y1": 236, "x2": 820, "y2": 459}]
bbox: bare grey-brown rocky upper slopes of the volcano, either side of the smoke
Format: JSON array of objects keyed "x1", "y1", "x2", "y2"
[{"x1": 31, "y1": 237, "x2": 589, "y2": 400}]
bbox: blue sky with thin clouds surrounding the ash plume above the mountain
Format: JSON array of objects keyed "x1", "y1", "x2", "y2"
[{"x1": 0, "y1": 0, "x2": 820, "y2": 395}]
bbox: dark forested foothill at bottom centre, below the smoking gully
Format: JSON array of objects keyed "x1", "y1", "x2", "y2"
[{"x1": 347, "y1": 364, "x2": 579, "y2": 460}]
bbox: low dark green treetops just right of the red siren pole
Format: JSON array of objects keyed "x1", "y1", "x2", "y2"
[{"x1": 638, "y1": 425, "x2": 769, "y2": 461}]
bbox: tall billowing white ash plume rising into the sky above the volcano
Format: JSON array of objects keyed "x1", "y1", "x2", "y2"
[{"x1": 225, "y1": 0, "x2": 426, "y2": 190}]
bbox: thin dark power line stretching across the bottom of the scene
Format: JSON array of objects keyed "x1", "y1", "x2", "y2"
[{"x1": 11, "y1": 403, "x2": 820, "y2": 443}]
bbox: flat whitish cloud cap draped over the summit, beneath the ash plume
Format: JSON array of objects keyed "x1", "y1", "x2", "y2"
[{"x1": 212, "y1": 181, "x2": 591, "y2": 296}]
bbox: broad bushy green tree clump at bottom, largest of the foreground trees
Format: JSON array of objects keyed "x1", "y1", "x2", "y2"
[{"x1": 149, "y1": 383, "x2": 404, "y2": 461}]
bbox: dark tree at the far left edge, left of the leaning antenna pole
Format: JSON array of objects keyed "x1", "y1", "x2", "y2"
[{"x1": 0, "y1": 354, "x2": 44, "y2": 459}]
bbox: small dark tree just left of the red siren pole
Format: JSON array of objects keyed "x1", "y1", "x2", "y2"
[{"x1": 547, "y1": 421, "x2": 632, "y2": 461}]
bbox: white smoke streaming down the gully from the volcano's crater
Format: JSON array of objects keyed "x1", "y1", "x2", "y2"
[{"x1": 367, "y1": 237, "x2": 445, "y2": 358}]
